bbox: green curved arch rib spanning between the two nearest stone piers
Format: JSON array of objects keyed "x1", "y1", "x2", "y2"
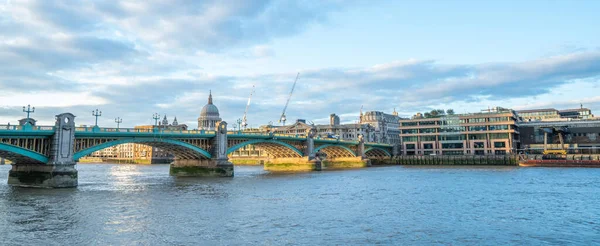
[{"x1": 73, "y1": 138, "x2": 212, "y2": 161}]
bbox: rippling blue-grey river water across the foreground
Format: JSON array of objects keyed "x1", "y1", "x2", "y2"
[{"x1": 0, "y1": 164, "x2": 600, "y2": 245}]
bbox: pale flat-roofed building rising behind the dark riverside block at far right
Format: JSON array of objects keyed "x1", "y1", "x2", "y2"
[{"x1": 516, "y1": 106, "x2": 594, "y2": 121}]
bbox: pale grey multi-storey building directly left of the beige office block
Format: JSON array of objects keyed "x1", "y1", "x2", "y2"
[{"x1": 359, "y1": 109, "x2": 404, "y2": 144}]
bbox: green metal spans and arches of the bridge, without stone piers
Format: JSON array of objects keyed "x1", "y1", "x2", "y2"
[{"x1": 0, "y1": 122, "x2": 393, "y2": 164}]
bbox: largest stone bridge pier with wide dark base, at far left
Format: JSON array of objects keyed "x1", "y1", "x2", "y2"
[{"x1": 8, "y1": 113, "x2": 78, "y2": 188}]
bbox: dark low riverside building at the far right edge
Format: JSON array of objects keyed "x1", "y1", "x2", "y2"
[{"x1": 519, "y1": 119, "x2": 600, "y2": 154}]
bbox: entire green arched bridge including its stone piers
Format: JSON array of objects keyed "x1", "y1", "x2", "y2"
[{"x1": 0, "y1": 113, "x2": 398, "y2": 187}]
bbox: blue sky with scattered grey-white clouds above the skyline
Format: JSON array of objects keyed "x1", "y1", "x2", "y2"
[{"x1": 0, "y1": 0, "x2": 600, "y2": 129}]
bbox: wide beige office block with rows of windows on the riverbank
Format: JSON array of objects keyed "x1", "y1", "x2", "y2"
[{"x1": 399, "y1": 108, "x2": 520, "y2": 155}]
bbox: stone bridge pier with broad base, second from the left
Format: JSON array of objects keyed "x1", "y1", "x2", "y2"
[{"x1": 169, "y1": 121, "x2": 233, "y2": 177}]
